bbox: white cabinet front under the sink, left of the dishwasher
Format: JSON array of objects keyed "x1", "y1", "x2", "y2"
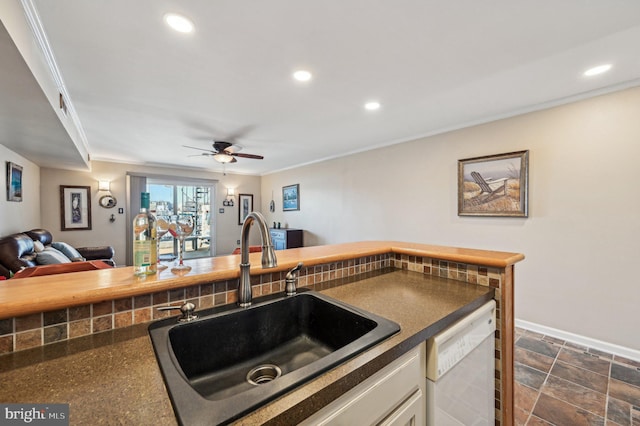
[{"x1": 301, "y1": 344, "x2": 426, "y2": 426}]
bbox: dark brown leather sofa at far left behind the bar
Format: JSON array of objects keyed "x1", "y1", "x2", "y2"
[{"x1": 0, "y1": 229, "x2": 115, "y2": 278}]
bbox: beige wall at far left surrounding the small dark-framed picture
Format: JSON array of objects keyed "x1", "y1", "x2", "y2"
[{"x1": 0, "y1": 145, "x2": 40, "y2": 236}]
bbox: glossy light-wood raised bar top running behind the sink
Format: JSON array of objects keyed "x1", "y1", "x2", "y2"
[{"x1": 0, "y1": 241, "x2": 524, "y2": 319}]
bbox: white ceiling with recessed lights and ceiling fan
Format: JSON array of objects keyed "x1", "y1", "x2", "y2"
[{"x1": 0, "y1": 0, "x2": 640, "y2": 174}]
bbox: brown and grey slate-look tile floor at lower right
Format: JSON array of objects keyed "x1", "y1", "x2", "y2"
[{"x1": 515, "y1": 328, "x2": 640, "y2": 426}]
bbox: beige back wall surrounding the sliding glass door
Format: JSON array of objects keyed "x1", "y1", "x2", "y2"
[{"x1": 41, "y1": 161, "x2": 261, "y2": 265}]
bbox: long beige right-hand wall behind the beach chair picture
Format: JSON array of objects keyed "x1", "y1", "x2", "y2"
[{"x1": 262, "y1": 88, "x2": 640, "y2": 350}]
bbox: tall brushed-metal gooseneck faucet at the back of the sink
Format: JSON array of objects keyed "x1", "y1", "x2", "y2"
[{"x1": 238, "y1": 212, "x2": 278, "y2": 308}]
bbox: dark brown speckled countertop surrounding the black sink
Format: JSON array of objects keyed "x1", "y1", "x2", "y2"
[{"x1": 0, "y1": 270, "x2": 493, "y2": 425}]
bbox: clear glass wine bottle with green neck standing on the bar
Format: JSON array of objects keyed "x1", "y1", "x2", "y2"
[{"x1": 133, "y1": 192, "x2": 158, "y2": 275}]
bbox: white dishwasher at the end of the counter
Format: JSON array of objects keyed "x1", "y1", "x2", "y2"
[{"x1": 426, "y1": 300, "x2": 496, "y2": 426}]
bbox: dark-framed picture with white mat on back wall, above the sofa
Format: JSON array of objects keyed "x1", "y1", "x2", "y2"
[{"x1": 60, "y1": 185, "x2": 91, "y2": 231}]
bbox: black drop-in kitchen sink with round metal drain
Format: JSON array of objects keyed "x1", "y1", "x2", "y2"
[{"x1": 149, "y1": 291, "x2": 400, "y2": 425}]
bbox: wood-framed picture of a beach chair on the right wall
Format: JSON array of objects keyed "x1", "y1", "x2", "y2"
[{"x1": 458, "y1": 150, "x2": 529, "y2": 217}]
